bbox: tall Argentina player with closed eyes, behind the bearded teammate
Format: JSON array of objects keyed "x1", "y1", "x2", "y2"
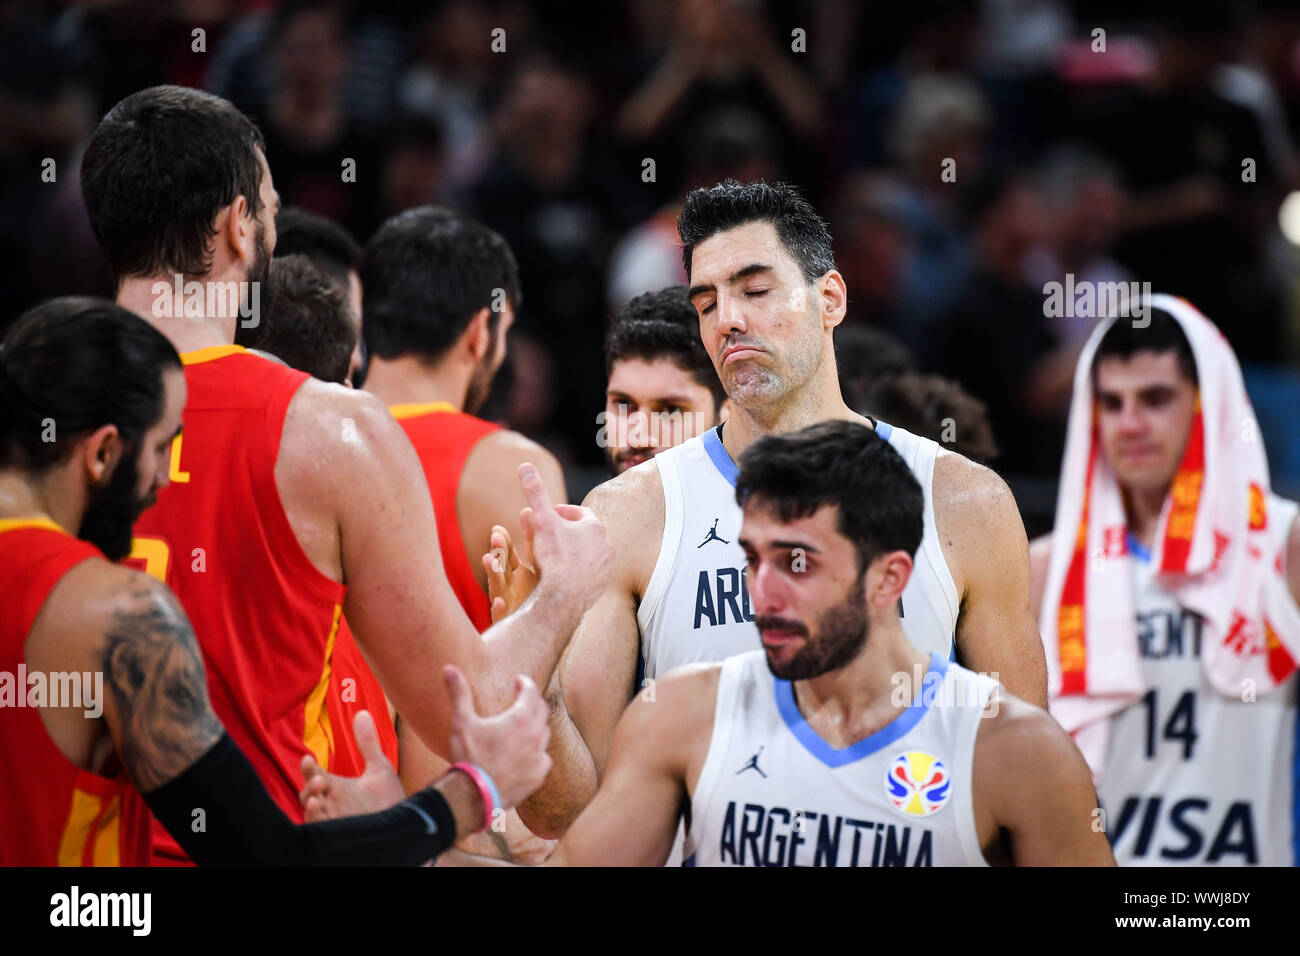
[{"x1": 563, "y1": 181, "x2": 1047, "y2": 832}]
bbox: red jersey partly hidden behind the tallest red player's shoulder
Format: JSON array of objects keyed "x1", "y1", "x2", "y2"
[{"x1": 389, "y1": 402, "x2": 501, "y2": 633}]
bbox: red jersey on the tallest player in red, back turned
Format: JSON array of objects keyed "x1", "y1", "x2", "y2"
[{"x1": 131, "y1": 345, "x2": 384, "y2": 865}]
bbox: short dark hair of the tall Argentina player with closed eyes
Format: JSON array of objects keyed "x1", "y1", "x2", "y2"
[{"x1": 677, "y1": 179, "x2": 835, "y2": 282}]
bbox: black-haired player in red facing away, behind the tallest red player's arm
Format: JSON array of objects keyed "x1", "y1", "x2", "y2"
[{"x1": 361, "y1": 207, "x2": 564, "y2": 860}]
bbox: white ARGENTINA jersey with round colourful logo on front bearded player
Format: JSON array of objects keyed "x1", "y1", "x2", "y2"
[{"x1": 685, "y1": 650, "x2": 997, "y2": 866}]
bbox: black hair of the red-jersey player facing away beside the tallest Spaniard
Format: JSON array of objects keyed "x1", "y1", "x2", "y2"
[{"x1": 361, "y1": 206, "x2": 520, "y2": 359}]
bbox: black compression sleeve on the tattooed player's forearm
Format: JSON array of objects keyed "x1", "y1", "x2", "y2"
[{"x1": 144, "y1": 734, "x2": 456, "y2": 866}]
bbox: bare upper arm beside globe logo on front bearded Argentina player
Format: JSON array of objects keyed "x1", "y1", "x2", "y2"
[{"x1": 974, "y1": 695, "x2": 1115, "y2": 866}]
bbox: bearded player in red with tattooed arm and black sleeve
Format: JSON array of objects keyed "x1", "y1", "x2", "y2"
[{"x1": 0, "y1": 298, "x2": 550, "y2": 866}]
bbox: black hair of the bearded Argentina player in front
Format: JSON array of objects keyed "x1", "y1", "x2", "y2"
[{"x1": 736, "y1": 421, "x2": 924, "y2": 572}]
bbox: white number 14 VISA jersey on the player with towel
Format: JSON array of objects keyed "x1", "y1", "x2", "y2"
[{"x1": 1097, "y1": 498, "x2": 1296, "y2": 866}]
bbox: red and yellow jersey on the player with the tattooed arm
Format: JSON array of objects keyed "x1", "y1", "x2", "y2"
[{"x1": 0, "y1": 519, "x2": 150, "y2": 866}]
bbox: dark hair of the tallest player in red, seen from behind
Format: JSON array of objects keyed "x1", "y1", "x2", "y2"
[{"x1": 81, "y1": 86, "x2": 265, "y2": 282}]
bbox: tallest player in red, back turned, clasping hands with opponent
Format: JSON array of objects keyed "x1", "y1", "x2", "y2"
[{"x1": 82, "y1": 87, "x2": 610, "y2": 861}]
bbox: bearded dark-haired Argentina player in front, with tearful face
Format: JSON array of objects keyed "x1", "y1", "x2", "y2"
[{"x1": 303, "y1": 421, "x2": 1113, "y2": 866}]
